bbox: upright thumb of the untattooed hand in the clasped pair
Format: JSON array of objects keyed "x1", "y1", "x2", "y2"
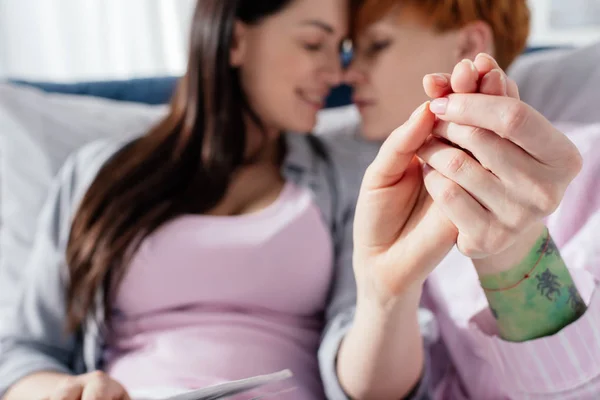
[{"x1": 363, "y1": 102, "x2": 435, "y2": 190}]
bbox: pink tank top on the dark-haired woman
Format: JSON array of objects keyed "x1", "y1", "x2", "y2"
[{"x1": 105, "y1": 183, "x2": 333, "y2": 399}]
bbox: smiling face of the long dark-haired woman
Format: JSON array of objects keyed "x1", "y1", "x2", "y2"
[{"x1": 231, "y1": 0, "x2": 348, "y2": 135}]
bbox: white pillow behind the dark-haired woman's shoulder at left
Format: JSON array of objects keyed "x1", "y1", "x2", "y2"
[{"x1": 0, "y1": 84, "x2": 166, "y2": 304}]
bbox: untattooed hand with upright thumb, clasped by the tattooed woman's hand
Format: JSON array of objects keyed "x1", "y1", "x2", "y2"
[{"x1": 354, "y1": 57, "x2": 508, "y2": 305}]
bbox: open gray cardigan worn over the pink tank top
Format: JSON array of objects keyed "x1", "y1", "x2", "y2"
[{"x1": 0, "y1": 132, "x2": 427, "y2": 400}]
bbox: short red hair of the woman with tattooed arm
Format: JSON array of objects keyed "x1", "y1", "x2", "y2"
[{"x1": 352, "y1": 0, "x2": 531, "y2": 69}]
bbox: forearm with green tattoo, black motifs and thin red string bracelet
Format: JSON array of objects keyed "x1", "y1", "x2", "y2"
[{"x1": 475, "y1": 223, "x2": 586, "y2": 342}]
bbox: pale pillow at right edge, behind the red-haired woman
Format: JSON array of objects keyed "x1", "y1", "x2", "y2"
[{"x1": 509, "y1": 43, "x2": 600, "y2": 124}]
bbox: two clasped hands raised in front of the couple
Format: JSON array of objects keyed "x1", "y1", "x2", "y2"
[{"x1": 354, "y1": 54, "x2": 582, "y2": 305}]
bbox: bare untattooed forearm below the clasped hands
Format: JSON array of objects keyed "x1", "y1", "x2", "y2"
[{"x1": 337, "y1": 290, "x2": 424, "y2": 400}]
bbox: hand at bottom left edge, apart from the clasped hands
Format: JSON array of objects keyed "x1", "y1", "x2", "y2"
[{"x1": 44, "y1": 371, "x2": 131, "y2": 400}]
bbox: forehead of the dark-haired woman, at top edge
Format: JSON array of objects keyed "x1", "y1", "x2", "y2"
[{"x1": 275, "y1": 0, "x2": 350, "y2": 36}]
